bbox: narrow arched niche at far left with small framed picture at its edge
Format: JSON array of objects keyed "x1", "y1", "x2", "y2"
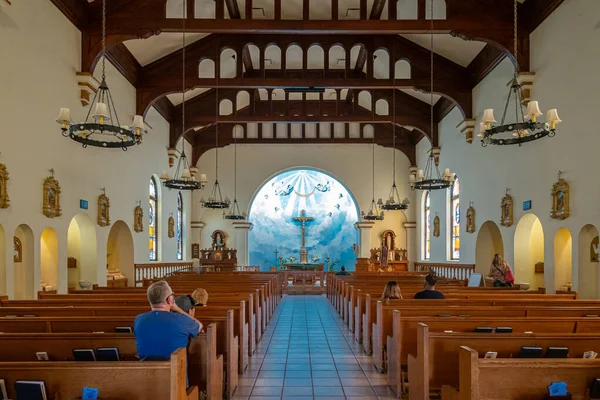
[{"x1": 13, "y1": 224, "x2": 33, "y2": 300}]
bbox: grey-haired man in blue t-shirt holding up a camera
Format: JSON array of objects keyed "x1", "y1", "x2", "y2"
[{"x1": 133, "y1": 281, "x2": 202, "y2": 360}]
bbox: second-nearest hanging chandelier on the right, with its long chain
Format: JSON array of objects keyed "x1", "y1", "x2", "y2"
[{"x1": 409, "y1": 1, "x2": 455, "y2": 190}]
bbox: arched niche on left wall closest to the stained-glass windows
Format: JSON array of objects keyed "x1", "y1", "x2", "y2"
[{"x1": 106, "y1": 220, "x2": 135, "y2": 286}]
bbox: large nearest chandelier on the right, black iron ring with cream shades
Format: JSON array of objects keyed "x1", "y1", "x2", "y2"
[{"x1": 477, "y1": 0, "x2": 562, "y2": 147}]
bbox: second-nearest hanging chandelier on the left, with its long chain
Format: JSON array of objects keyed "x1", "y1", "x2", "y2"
[{"x1": 160, "y1": 1, "x2": 207, "y2": 191}]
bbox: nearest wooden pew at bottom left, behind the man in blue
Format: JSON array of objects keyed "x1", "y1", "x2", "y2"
[{"x1": 0, "y1": 349, "x2": 198, "y2": 400}]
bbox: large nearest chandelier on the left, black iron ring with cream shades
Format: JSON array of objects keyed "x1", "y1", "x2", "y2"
[{"x1": 56, "y1": 0, "x2": 147, "y2": 151}]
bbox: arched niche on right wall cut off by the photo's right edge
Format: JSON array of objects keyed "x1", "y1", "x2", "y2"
[{"x1": 577, "y1": 224, "x2": 600, "y2": 299}]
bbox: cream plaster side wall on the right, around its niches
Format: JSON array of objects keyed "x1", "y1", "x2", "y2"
[{"x1": 417, "y1": 0, "x2": 600, "y2": 290}]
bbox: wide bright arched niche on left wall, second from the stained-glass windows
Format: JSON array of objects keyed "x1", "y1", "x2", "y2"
[{"x1": 67, "y1": 213, "x2": 98, "y2": 289}]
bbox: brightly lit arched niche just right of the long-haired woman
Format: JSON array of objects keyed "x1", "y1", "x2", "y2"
[{"x1": 514, "y1": 214, "x2": 544, "y2": 289}]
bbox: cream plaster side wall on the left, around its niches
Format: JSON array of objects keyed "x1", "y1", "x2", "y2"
[{"x1": 0, "y1": 1, "x2": 191, "y2": 295}]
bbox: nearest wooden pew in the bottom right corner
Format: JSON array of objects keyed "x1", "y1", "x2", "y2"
[{"x1": 442, "y1": 346, "x2": 600, "y2": 400}]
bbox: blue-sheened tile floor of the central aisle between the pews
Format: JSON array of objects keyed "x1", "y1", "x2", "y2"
[{"x1": 234, "y1": 295, "x2": 395, "y2": 400}]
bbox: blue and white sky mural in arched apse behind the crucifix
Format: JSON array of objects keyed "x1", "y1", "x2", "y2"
[{"x1": 248, "y1": 169, "x2": 358, "y2": 270}]
